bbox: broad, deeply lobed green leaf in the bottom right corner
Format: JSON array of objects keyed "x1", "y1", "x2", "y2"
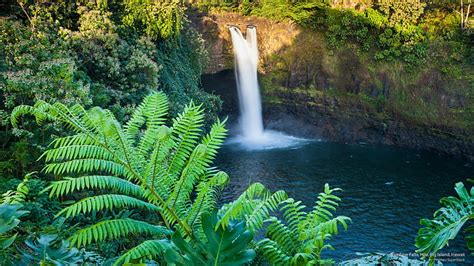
[{"x1": 416, "y1": 182, "x2": 474, "y2": 261}]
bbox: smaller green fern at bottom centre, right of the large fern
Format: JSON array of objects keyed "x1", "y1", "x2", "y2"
[{"x1": 257, "y1": 184, "x2": 350, "y2": 265}]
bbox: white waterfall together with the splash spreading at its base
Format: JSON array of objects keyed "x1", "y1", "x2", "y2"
[{"x1": 227, "y1": 26, "x2": 309, "y2": 150}]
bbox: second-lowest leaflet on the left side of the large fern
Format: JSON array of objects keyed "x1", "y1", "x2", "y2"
[{"x1": 68, "y1": 219, "x2": 171, "y2": 247}]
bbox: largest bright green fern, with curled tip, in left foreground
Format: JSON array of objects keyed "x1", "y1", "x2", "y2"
[{"x1": 11, "y1": 93, "x2": 228, "y2": 261}]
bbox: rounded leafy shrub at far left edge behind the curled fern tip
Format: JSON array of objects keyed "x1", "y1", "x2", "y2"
[{"x1": 0, "y1": 18, "x2": 90, "y2": 179}]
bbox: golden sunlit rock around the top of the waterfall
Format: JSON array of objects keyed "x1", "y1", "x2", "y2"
[{"x1": 189, "y1": 12, "x2": 301, "y2": 74}]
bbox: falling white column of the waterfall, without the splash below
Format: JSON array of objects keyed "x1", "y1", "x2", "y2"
[{"x1": 230, "y1": 26, "x2": 263, "y2": 139}]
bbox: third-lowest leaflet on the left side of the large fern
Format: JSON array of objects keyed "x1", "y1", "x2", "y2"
[{"x1": 56, "y1": 194, "x2": 161, "y2": 218}]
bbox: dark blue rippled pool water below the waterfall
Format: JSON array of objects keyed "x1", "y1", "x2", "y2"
[{"x1": 217, "y1": 141, "x2": 474, "y2": 265}]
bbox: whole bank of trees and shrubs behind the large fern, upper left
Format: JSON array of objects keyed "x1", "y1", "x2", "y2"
[{"x1": 0, "y1": 1, "x2": 221, "y2": 181}]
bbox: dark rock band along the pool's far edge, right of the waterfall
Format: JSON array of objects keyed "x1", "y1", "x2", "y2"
[{"x1": 264, "y1": 89, "x2": 474, "y2": 160}]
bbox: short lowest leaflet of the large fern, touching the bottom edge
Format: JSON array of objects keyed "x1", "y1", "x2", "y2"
[{"x1": 114, "y1": 239, "x2": 170, "y2": 265}]
